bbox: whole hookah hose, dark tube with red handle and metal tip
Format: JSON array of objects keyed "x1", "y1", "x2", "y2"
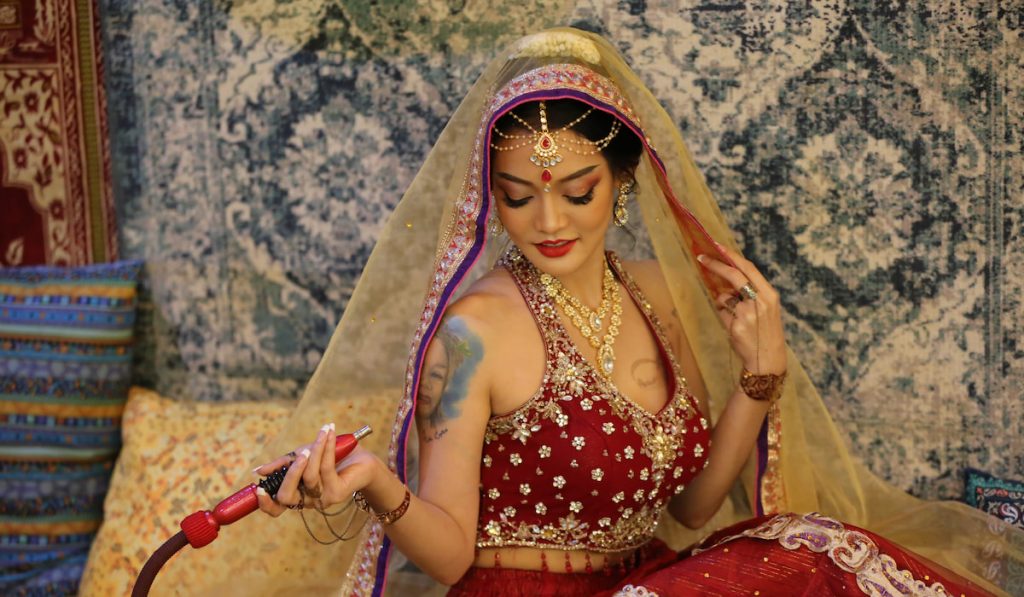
[{"x1": 131, "y1": 426, "x2": 372, "y2": 597}]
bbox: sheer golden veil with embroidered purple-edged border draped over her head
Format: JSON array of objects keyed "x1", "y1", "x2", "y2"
[{"x1": 158, "y1": 29, "x2": 1024, "y2": 595}]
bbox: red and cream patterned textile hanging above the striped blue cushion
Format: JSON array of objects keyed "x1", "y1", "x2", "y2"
[{"x1": 0, "y1": 0, "x2": 117, "y2": 267}]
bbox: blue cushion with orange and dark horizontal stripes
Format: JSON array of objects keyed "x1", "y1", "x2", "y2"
[{"x1": 0, "y1": 261, "x2": 141, "y2": 595}]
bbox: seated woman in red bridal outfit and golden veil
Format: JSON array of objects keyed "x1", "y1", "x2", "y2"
[{"x1": 247, "y1": 30, "x2": 1019, "y2": 595}]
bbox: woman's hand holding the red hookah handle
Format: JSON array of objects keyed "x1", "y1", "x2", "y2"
[{"x1": 254, "y1": 424, "x2": 384, "y2": 517}]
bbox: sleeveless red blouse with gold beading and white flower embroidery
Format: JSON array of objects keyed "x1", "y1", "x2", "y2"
[{"x1": 476, "y1": 251, "x2": 711, "y2": 552}]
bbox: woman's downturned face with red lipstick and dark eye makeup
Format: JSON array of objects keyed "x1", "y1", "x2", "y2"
[{"x1": 490, "y1": 130, "x2": 617, "y2": 278}]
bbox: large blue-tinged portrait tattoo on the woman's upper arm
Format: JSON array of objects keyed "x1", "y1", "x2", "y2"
[{"x1": 416, "y1": 316, "x2": 483, "y2": 443}]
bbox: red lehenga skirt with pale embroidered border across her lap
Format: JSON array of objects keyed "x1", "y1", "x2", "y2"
[{"x1": 449, "y1": 514, "x2": 990, "y2": 597}]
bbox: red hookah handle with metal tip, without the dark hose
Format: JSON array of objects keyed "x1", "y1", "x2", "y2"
[{"x1": 181, "y1": 425, "x2": 373, "y2": 549}]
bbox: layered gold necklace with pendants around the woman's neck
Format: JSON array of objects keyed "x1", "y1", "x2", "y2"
[{"x1": 541, "y1": 263, "x2": 623, "y2": 381}]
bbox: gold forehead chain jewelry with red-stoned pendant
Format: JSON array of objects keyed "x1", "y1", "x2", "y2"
[{"x1": 490, "y1": 101, "x2": 622, "y2": 193}]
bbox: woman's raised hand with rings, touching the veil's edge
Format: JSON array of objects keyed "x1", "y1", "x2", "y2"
[{"x1": 697, "y1": 246, "x2": 786, "y2": 374}]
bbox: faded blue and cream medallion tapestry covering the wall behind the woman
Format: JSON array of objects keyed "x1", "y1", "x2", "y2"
[{"x1": 102, "y1": 0, "x2": 1024, "y2": 497}]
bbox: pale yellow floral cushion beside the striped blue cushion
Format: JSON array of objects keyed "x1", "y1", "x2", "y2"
[{"x1": 80, "y1": 387, "x2": 294, "y2": 596}]
